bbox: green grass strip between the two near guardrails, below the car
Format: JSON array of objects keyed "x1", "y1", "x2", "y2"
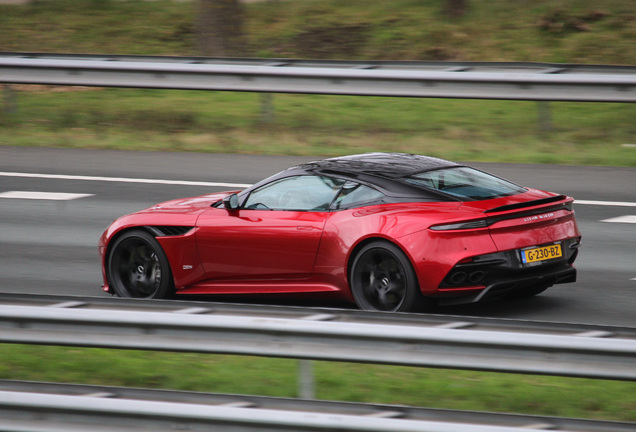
[{"x1": 0, "y1": 344, "x2": 636, "y2": 422}]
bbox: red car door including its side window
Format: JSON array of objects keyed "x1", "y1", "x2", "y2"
[{"x1": 196, "y1": 175, "x2": 343, "y2": 280}]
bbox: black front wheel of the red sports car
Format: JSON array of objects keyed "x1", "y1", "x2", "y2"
[{"x1": 107, "y1": 230, "x2": 174, "y2": 299}]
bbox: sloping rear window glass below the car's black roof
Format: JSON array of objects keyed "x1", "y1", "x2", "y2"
[{"x1": 405, "y1": 167, "x2": 527, "y2": 201}]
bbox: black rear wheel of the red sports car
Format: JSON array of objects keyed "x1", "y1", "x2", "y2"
[{"x1": 349, "y1": 241, "x2": 426, "y2": 312}]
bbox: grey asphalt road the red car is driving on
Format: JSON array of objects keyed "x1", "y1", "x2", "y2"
[{"x1": 0, "y1": 146, "x2": 636, "y2": 327}]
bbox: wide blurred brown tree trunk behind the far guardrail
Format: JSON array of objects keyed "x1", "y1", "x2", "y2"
[{"x1": 196, "y1": 0, "x2": 243, "y2": 57}]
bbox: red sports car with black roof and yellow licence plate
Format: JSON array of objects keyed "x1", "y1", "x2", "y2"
[{"x1": 99, "y1": 153, "x2": 581, "y2": 312}]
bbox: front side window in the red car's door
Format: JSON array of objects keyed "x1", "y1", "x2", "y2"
[{"x1": 243, "y1": 175, "x2": 344, "y2": 211}]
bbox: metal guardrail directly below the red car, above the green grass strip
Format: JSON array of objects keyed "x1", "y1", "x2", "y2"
[{"x1": 0, "y1": 299, "x2": 636, "y2": 381}]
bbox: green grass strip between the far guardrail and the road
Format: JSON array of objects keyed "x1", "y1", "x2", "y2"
[{"x1": 0, "y1": 86, "x2": 636, "y2": 166}]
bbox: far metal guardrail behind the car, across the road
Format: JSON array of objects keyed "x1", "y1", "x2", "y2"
[{"x1": 0, "y1": 52, "x2": 636, "y2": 102}]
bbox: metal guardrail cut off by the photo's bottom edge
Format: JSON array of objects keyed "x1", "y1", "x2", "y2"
[{"x1": 0, "y1": 381, "x2": 636, "y2": 432}]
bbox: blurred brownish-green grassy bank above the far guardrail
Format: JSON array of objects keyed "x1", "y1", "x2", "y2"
[{"x1": 0, "y1": 0, "x2": 636, "y2": 64}]
